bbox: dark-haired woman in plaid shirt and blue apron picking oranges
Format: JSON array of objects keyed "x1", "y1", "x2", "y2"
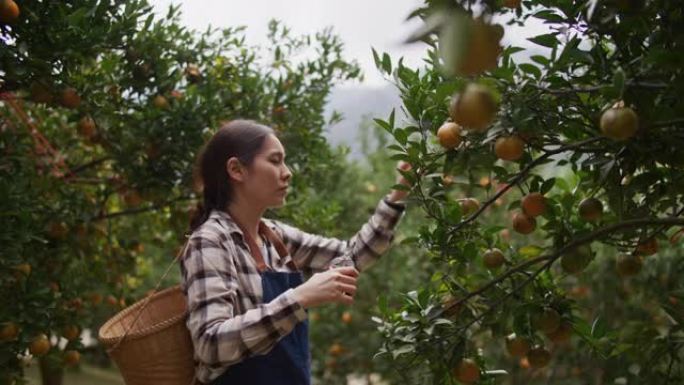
[{"x1": 181, "y1": 120, "x2": 406, "y2": 385}]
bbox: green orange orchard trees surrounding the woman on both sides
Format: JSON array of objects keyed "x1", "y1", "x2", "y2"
[{"x1": 0, "y1": 0, "x2": 684, "y2": 384}]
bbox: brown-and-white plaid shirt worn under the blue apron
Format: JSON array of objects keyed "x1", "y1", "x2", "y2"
[{"x1": 181, "y1": 199, "x2": 403, "y2": 383}]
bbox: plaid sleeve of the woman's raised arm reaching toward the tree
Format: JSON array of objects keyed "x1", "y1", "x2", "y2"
[{"x1": 274, "y1": 199, "x2": 404, "y2": 274}]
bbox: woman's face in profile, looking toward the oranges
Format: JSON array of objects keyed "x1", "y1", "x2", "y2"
[{"x1": 243, "y1": 135, "x2": 292, "y2": 208}]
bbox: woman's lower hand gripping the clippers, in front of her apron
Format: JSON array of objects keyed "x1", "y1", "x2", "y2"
[{"x1": 294, "y1": 267, "x2": 359, "y2": 308}]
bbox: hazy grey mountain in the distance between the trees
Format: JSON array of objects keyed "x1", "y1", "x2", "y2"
[{"x1": 325, "y1": 84, "x2": 401, "y2": 159}]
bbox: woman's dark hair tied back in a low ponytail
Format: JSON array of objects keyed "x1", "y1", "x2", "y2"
[{"x1": 190, "y1": 120, "x2": 274, "y2": 231}]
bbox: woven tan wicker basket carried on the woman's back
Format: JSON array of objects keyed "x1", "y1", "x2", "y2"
[{"x1": 99, "y1": 286, "x2": 195, "y2": 385}]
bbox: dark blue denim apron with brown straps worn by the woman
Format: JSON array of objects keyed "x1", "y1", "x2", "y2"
[{"x1": 211, "y1": 219, "x2": 311, "y2": 385}]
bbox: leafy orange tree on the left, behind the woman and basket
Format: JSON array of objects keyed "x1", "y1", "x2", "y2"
[{"x1": 0, "y1": 0, "x2": 360, "y2": 384}]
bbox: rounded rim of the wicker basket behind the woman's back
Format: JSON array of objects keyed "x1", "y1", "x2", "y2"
[{"x1": 98, "y1": 285, "x2": 187, "y2": 345}]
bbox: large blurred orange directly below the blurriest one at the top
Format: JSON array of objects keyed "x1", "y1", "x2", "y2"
[{"x1": 449, "y1": 83, "x2": 498, "y2": 132}]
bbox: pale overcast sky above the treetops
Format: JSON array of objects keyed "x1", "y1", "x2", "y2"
[{"x1": 150, "y1": 0, "x2": 425, "y2": 85}]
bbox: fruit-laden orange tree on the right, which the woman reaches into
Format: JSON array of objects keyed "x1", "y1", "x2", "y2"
[{"x1": 374, "y1": 0, "x2": 684, "y2": 384}]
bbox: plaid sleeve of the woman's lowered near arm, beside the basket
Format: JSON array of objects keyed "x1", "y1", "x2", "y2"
[{"x1": 181, "y1": 234, "x2": 306, "y2": 367}]
